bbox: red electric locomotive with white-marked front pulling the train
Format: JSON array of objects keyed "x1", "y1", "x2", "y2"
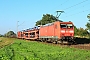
[{"x1": 39, "y1": 21, "x2": 74, "y2": 43}]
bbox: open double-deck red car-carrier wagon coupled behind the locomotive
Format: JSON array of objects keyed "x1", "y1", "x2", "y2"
[{"x1": 17, "y1": 27, "x2": 39, "y2": 40}]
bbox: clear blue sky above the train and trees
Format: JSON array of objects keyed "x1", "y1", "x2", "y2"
[{"x1": 0, "y1": 0, "x2": 90, "y2": 34}]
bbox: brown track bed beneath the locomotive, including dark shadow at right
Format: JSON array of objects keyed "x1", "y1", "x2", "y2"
[{"x1": 23, "y1": 38, "x2": 90, "y2": 50}]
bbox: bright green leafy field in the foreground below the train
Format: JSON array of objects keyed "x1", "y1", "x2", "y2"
[{"x1": 0, "y1": 39, "x2": 90, "y2": 60}]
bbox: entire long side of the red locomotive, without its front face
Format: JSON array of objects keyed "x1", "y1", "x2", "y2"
[{"x1": 39, "y1": 21, "x2": 60, "y2": 42}]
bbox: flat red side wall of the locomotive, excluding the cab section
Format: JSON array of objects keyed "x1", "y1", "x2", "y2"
[{"x1": 39, "y1": 24, "x2": 55, "y2": 38}]
